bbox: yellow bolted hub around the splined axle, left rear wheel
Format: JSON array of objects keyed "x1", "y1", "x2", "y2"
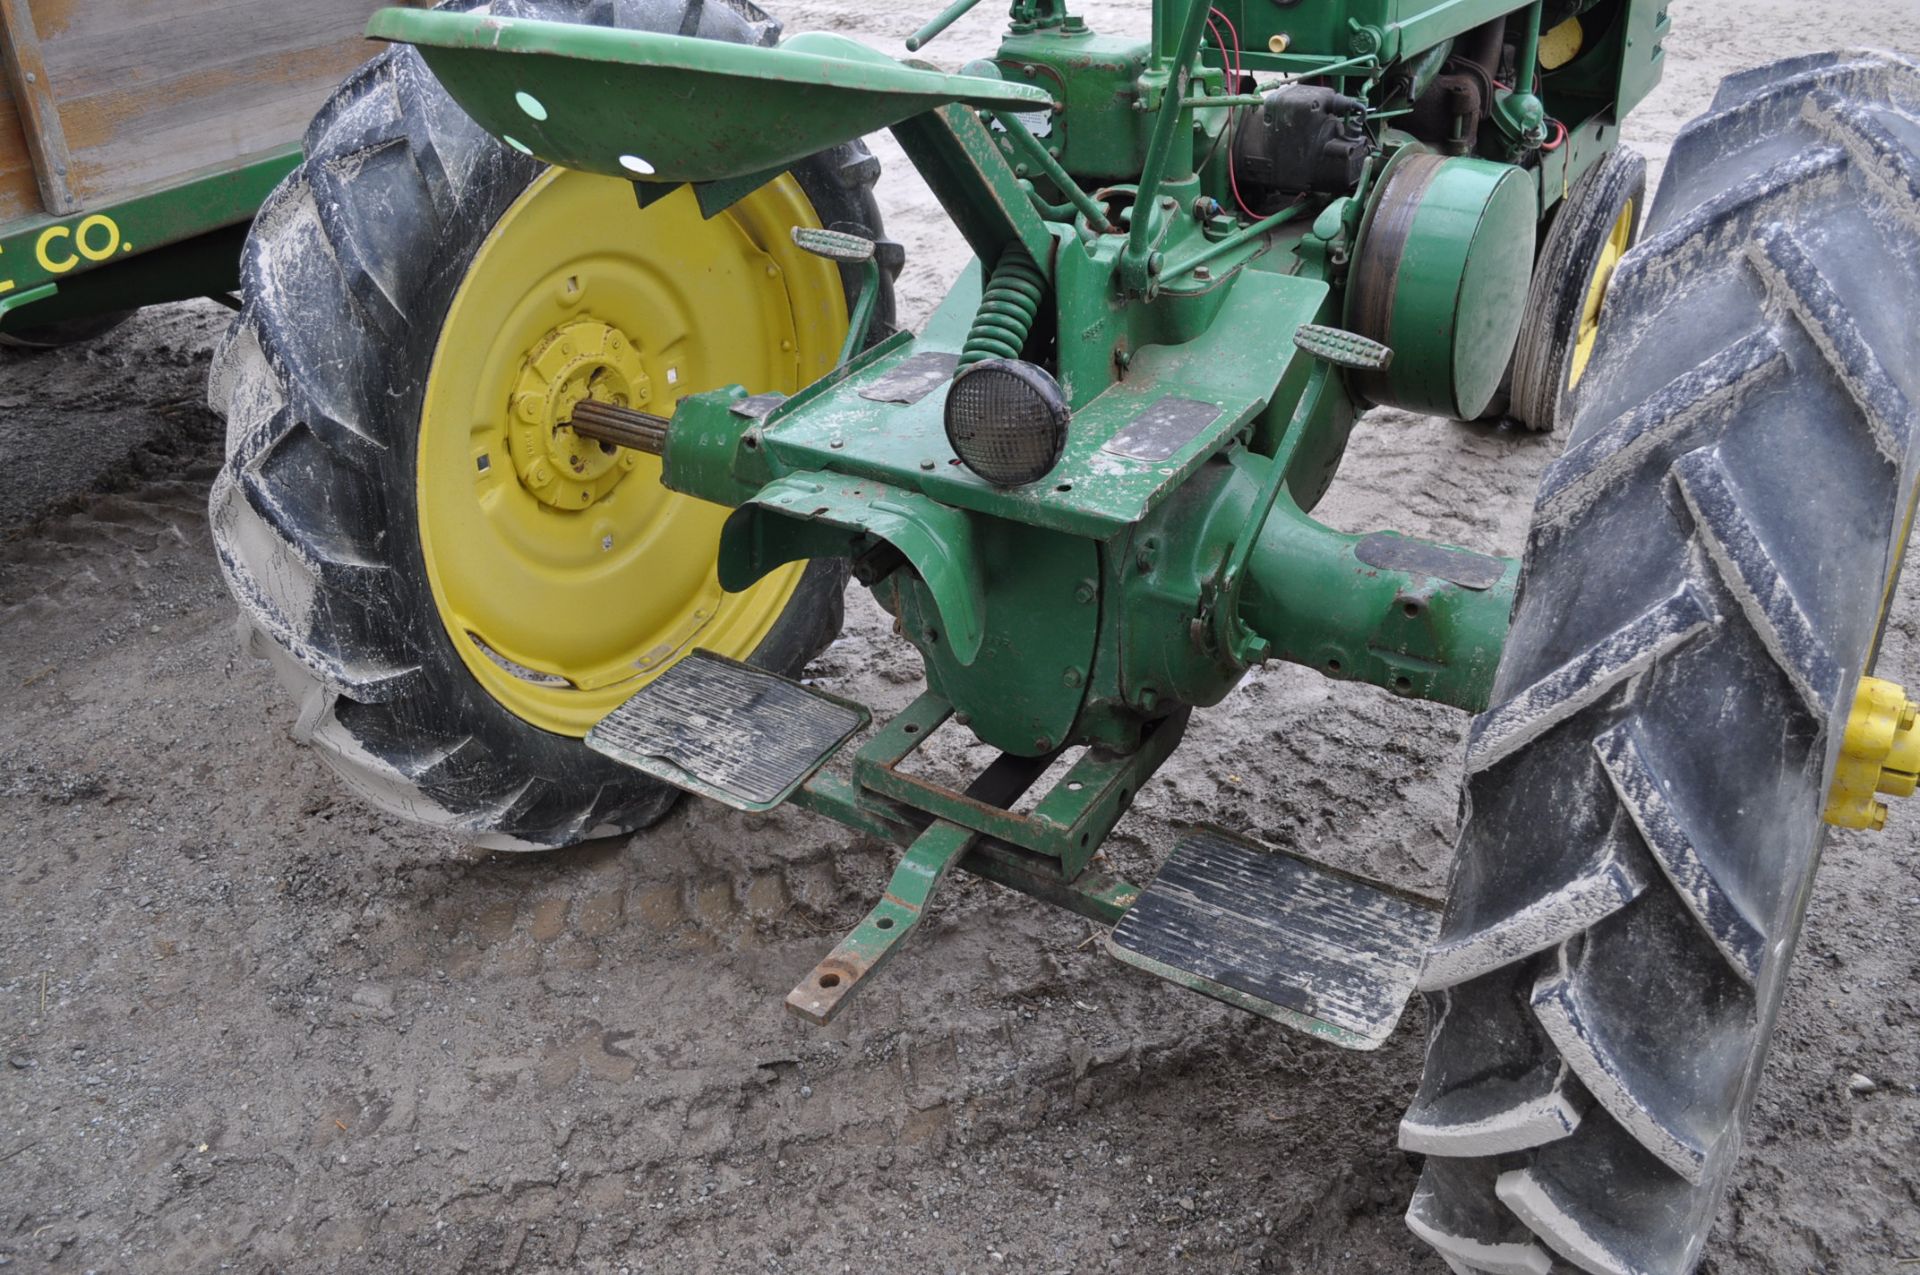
[{"x1": 507, "y1": 315, "x2": 653, "y2": 511}]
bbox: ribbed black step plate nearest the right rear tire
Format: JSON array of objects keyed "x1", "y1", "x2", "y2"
[{"x1": 1108, "y1": 831, "x2": 1440, "y2": 1048}]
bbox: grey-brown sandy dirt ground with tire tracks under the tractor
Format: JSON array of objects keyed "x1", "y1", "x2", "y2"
[{"x1": 0, "y1": 0, "x2": 1920, "y2": 1275}]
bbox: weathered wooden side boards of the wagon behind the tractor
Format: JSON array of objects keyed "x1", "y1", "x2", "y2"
[{"x1": 0, "y1": 0, "x2": 428, "y2": 223}]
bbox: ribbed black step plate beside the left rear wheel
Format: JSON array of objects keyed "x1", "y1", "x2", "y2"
[{"x1": 588, "y1": 651, "x2": 868, "y2": 810}]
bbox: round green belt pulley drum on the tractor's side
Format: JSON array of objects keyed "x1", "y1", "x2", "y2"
[{"x1": 1346, "y1": 150, "x2": 1538, "y2": 421}]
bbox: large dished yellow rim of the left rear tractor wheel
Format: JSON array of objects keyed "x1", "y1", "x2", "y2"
[{"x1": 417, "y1": 169, "x2": 847, "y2": 735}]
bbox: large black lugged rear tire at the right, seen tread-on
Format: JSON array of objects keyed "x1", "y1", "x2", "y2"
[{"x1": 1400, "y1": 54, "x2": 1920, "y2": 1275}]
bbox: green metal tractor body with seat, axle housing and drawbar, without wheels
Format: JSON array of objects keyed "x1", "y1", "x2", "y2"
[{"x1": 371, "y1": 0, "x2": 1665, "y2": 983}]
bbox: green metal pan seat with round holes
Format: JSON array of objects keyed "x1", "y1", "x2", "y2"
[{"x1": 367, "y1": 10, "x2": 1050, "y2": 182}]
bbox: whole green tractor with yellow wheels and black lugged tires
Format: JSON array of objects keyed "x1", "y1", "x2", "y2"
[{"x1": 211, "y1": 0, "x2": 1920, "y2": 1275}]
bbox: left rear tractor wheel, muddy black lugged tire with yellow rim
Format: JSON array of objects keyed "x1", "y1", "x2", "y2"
[{"x1": 211, "y1": 0, "x2": 899, "y2": 849}]
